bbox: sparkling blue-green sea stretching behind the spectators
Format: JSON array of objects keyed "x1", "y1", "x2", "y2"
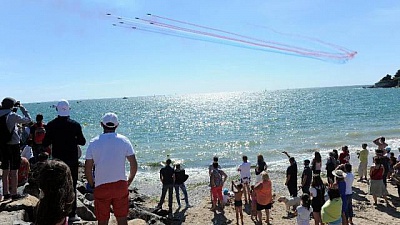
[{"x1": 24, "y1": 86, "x2": 400, "y2": 194}]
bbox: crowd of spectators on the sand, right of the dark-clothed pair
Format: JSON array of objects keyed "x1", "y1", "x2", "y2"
[{"x1": 202, "y1": 141, "x2": 400, "y2": 225}]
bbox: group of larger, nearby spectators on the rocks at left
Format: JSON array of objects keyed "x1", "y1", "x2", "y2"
[{"x1": 0, "y1": 97, "x2": 137, "y2": 225}]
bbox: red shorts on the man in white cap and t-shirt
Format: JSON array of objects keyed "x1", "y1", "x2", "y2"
[{"x1": 94, "y1": 180, "x2": 129, "y2": 221}]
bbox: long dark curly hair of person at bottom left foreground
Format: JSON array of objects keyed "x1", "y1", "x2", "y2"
[{"x1": 35, "y1": 160, "x2": 75, "y2": 225}]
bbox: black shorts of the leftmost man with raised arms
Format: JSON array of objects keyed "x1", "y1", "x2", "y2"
[{"x1": 1, "y1": 144, "x2": 21, "y2": 170}]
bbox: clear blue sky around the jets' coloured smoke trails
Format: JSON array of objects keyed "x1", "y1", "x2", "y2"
[{"x1": 0, "y1": 0, "x2": 400, "y2": 102}]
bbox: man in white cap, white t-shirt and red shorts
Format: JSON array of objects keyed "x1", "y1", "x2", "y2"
[{"x1": 85, "y1": 113, "x2": 137, "y2": 225}]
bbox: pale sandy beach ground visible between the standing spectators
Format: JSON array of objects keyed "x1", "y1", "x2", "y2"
[{"x1": 146, "y1": 174, "x2": 400, "y2": 225}]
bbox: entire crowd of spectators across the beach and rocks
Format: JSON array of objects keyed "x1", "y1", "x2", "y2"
[{"x1": 0, "y1": 98, "x2": 400, "y2": 225}]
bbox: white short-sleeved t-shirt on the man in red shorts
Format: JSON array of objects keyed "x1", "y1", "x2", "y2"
[{"x1": 86, "y1": 133, "x2": 135, "y2": 187}]
